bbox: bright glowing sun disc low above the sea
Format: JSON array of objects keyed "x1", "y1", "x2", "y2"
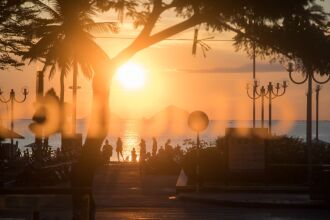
[{"x1": 115, "y1": 62, "x2": 146, "y2": 90}]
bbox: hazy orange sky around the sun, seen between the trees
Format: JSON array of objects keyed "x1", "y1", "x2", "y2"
[{"x1": 0, "y1": 0, "x2": 330, "y2": 120}]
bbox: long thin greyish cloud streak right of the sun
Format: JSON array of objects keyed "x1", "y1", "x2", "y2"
[{"x1": 178, "y1": 63, "x2": 285, "y2": 73}]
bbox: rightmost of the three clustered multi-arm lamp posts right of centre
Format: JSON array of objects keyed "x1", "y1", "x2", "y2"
[{"x1": 266, "y1": 81, "x2": 288, "y2": 134}]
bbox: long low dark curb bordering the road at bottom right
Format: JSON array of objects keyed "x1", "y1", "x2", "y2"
[{"x1": 178, "y1": 194, "x2": 330, "y2": 209}]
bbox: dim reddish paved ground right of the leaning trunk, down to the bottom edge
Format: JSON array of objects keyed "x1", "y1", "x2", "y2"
[{"x1": 94, "y1": 164, "x2": 330, "y2": 220}]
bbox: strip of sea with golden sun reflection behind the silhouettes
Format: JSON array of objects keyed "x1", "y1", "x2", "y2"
[{"x1": 7, "y1": 119, "x2": 330, "y2": 157}]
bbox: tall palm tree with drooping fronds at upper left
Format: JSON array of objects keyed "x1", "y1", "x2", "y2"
[{"x1": 24, "y1": 0, "x2": 117, "y2": 134}]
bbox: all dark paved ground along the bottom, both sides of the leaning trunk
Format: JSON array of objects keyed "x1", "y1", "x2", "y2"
[{"x1": 0, "y1": 164, "x2": 330, "y2": 220}]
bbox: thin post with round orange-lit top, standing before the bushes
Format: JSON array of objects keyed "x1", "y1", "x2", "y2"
[{"x1": 188, "y1": 111, "x2": 209, "y2": 192}]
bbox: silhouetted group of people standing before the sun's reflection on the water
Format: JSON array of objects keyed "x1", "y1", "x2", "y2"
[{"x1": 102, "y1": 137, "x2": 158, "y2": 163}]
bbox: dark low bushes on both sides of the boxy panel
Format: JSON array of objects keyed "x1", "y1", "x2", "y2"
[{"x1": 181, "y1": 136, "x2": 330, "y2": 184}]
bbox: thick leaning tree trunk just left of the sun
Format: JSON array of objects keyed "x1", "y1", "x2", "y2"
[{"x1": 71, "y1": 62, "x2": 112, "y2": 220}]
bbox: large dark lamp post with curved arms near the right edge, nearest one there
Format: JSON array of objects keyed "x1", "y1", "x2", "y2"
[{"x1": 287, "y1": 62, "x2": 330, "y2": 182}]
